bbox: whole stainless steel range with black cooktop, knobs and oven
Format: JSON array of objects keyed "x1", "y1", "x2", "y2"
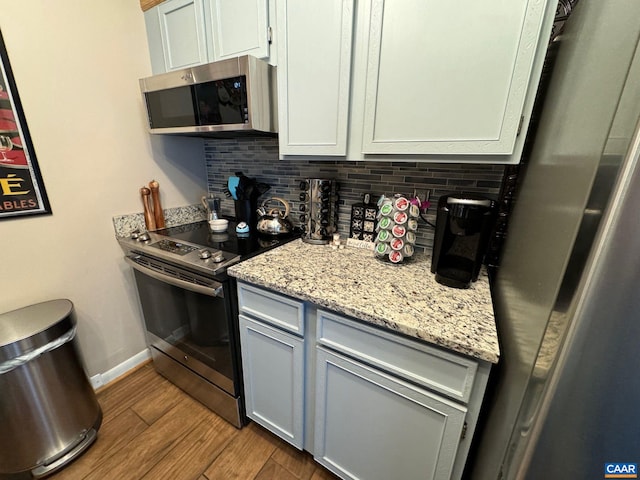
[{"x1": 118, "y1": 219, "x2": 295, "y2": 428}]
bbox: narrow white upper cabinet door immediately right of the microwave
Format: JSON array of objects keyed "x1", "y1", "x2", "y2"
[{"x1": 277, "y1": 0, "x2": 354, "y2": 155}]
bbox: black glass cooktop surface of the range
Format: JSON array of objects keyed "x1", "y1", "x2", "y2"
[{"x1": 154, "y1": 217, "x2": 300, "y2": 260}]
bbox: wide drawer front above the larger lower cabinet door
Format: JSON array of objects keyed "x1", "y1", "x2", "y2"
[{"x1": 317, "y1": 310, "x2": 478, "y2": 403}]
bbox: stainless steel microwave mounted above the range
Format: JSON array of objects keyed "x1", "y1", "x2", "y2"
[{"x1": 140, "y1": 55, "x2": 278, "y2": 136}]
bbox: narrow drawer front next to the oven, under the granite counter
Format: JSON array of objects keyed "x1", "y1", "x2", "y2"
[{"x1": 238, "y1": 282, "x2": 304, "y2": 335}]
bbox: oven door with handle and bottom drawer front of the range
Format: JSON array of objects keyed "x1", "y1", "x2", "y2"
[{"x1": 126, "y1": 253, "x2": 243, "y2": 427}]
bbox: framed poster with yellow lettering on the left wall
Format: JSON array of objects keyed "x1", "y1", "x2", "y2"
[{"x1": 0, "y1": 32, "x2": 51, "y2": 220}]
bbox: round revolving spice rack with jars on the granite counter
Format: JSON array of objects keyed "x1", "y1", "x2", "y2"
[{"x1": 299, "y1": 178, "x2": 339, "y2": 245}]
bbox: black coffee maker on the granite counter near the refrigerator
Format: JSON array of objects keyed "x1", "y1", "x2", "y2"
[{"x1": 431, "y1": 193, "x2": 495, "y2": 288}]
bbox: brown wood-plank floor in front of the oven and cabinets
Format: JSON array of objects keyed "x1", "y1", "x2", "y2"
[{"x1": 49, "y1": 364, "x2": 337, "y2": 480}]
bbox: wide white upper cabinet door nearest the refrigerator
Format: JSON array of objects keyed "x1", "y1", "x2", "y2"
[{"x1": 363, "y1": 0, "x2": 547, "y2": 155}]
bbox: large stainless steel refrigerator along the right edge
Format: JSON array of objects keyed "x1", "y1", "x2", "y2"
[{"x1": 467, "y1": 0, "x2": 640, "y2": 480}]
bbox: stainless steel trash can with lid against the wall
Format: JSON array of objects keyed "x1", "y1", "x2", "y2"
[{"x1": 0, "y1": 299, "x2": 102, "y2": 479}]
